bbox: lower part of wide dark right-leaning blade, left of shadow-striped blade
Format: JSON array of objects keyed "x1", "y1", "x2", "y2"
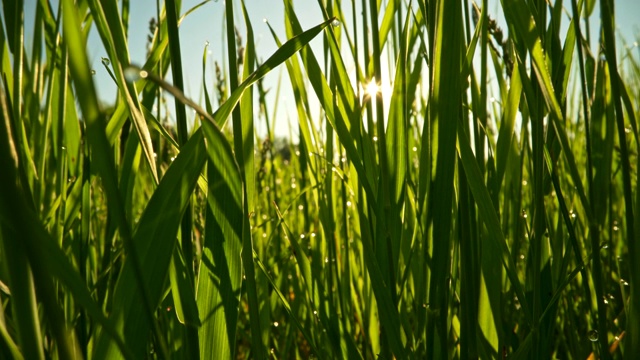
[{"x1": 96, "y1": 132, "x2": 207, "y2": 358}]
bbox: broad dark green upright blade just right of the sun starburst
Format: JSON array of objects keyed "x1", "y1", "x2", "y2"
[{"x1": 425, "y1": 1, "x2": 462, "y2": 357}]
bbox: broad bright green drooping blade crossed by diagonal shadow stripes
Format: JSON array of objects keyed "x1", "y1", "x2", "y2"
[{"x1": 196, "y1": 122, "x2": 248, "y2": 358}]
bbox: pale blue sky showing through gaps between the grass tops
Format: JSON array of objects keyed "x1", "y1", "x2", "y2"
[{"x1": 18, "y1": 0, "x2": 640, "y2": 135}]
